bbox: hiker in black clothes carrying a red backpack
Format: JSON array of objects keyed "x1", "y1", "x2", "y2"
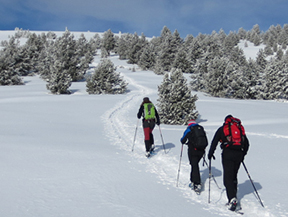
[{"x1": 208, "y1": 115, "x2": 249, "y2": 211}]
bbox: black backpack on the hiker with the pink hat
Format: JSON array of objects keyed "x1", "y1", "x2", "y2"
[{"x1": 191, "y1": 125, "x2": 208, "y2": 150}]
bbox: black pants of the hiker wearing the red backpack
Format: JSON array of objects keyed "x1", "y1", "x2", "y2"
[{"x1": 222, "y1": 149, "x2": 243, "y2": 202}]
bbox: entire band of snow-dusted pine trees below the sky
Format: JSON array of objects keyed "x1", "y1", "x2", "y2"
[{"x1": 0, "y1": 24, "x2": 288, "y2": 124}]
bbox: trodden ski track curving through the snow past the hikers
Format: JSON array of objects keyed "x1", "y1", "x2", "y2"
[{"x1": 102, "y1": 71, "x2": 280, "y2": 217}]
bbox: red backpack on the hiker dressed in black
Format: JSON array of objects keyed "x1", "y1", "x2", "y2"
[{"x1": 223, "y1": 117, "x2": 245, "y2": 149}]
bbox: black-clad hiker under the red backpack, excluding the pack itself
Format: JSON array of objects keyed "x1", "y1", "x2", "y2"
[{"x1": 208, "y1": 115, "x2": 249, "y2": 211}]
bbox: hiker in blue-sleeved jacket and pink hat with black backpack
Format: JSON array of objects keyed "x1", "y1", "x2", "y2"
[{"x1": 180, "y1": 119, "x2": 208, "y2": 194}]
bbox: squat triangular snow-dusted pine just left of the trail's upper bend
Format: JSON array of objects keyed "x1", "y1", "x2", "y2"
[{"x1": 86, "y1": 59, "x2": 128, "y2": 94}]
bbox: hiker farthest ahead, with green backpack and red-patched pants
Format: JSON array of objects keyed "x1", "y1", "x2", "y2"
[{"x1": 137, "y1": 97, "x2": 160, "y2": 157}]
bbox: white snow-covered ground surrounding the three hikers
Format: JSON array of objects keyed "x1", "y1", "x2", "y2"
[{"x1": 0, "y1": 32, "x2": 288, "y2": 217}]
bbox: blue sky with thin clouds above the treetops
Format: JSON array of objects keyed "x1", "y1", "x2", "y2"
[{"x1": 0, "y1": 0, "x2": 288, "y2": 38}]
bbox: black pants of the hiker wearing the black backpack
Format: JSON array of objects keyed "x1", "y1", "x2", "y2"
[{"x1": 188, "y1": 148, "x2": 204, "y2": 184}]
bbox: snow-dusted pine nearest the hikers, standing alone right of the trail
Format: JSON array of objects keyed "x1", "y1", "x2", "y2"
[{"x1": 157, "y1": 69, "x2": 198, "y2": 125}]
